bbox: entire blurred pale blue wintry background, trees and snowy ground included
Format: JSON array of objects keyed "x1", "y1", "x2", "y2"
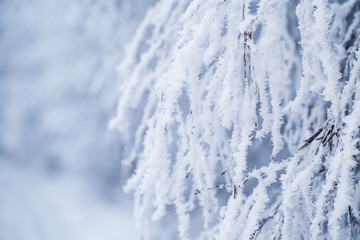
[{"x1": 0, "y1": 0, "x2": 155, "y2": 240}]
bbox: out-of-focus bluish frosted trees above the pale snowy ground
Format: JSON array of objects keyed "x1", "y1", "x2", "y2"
[{"x1": 0, "y1": 0, "x2": 155, "y2": 188}]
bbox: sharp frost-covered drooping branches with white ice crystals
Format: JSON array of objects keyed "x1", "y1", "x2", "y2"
[{"x1": 110, "y1": 0, "x2": 360, "y2": 240}]
